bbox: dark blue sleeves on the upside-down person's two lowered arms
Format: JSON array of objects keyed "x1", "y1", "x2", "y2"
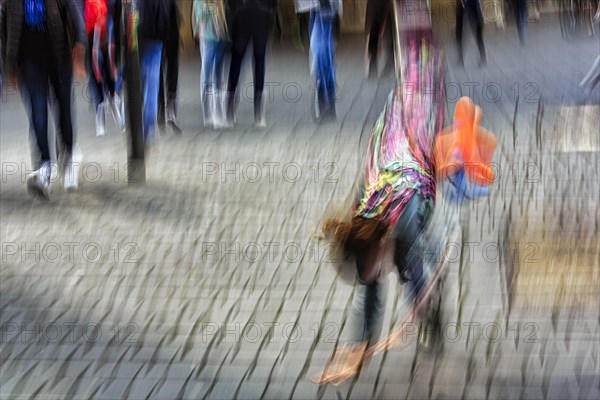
[{"x1": 350, "y1": 194, "x2": 428, "y2": 342}]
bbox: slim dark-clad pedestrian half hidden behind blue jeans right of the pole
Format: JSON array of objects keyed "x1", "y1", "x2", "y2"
[{"x1": 158, "y1": 1, "x2": 181, "y2": 133}]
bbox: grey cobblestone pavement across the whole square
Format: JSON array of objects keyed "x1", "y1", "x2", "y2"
[{"x1": 0, "y1": 16, "x2": 600, "y2": 400}]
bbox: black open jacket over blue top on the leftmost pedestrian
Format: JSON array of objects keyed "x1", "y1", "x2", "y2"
[{"x1": 0, "y1": 0, "x2": 87, "y2": 73}]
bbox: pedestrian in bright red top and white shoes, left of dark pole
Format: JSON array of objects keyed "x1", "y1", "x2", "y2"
[{"x1": 84, "y1": 0, "x2": 125, "y2": 136}]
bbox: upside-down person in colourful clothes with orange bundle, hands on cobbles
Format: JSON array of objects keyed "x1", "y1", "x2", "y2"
[{"x1": 314, "y1": 5, "x2": 497, "y2": 385}]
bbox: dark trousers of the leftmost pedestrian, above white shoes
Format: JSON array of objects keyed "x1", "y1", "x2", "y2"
[{"x1": 19, "y1": 59, "x2": 74, "y2": 162}]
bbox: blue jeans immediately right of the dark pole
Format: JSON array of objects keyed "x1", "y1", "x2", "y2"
[{"x1": 140, "y1": 40, "x2": 163, "y2": 143}]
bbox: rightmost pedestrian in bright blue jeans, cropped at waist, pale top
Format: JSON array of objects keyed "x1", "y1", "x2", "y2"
[{"x1": 310, "y1": 0, "x2": 342, "y2": 119}]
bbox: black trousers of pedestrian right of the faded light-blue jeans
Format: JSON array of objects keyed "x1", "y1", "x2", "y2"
[{"x1": 227, "y1": 8, "x2": 271, "y2": 96}]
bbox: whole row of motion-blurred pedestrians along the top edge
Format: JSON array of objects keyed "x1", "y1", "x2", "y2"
[{"x1": 0, "y1": 0, "x2": 596, "y2": 197}]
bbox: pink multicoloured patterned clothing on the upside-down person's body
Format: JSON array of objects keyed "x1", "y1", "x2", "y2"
[{"x1": 354, "y1": 40, "x2": 444, "y2": 227}]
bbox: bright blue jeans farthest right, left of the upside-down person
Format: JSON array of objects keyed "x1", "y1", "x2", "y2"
[{"x1": 310, "y1": 10, "x2": 336, "y2": 110}]
